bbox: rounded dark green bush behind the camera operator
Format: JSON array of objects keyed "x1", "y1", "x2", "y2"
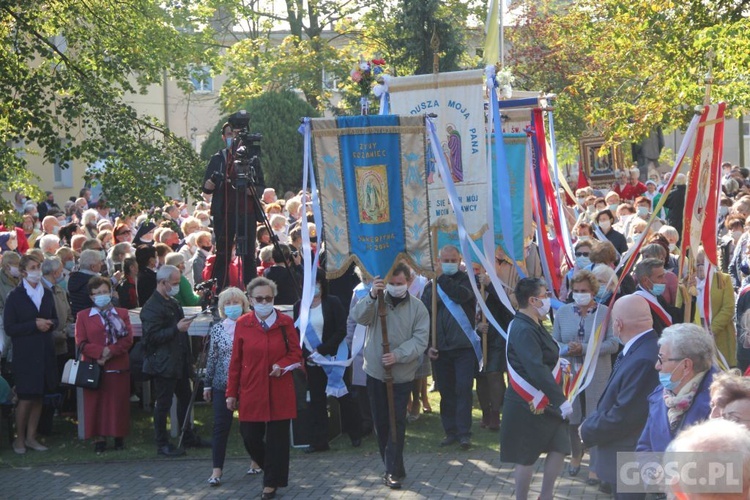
[{"x1": 201, "y1": 90, "x2": 318, "y2": 192}]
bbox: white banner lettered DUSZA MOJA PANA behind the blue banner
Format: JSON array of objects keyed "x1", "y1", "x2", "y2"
[{"x1": 388, "y1": 70, "x2": 491, "y2": 246}]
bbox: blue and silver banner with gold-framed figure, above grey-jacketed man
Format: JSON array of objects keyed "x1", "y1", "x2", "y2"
[{"x1": 310, "y1": 115, "x2": 433, "y2": 278}]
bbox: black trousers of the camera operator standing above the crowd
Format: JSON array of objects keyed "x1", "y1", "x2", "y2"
[{"x1": 213, "y1": 208, "x2": 258, "y2": 291}]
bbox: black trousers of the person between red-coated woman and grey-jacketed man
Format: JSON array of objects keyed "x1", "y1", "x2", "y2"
[{"x1": 306, "y1": 365, "x2": 362, "y2": 447}]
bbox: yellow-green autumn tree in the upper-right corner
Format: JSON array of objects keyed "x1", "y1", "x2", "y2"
[{"x1": 509, "y1": 0, "x2": 750, "y2": 148}]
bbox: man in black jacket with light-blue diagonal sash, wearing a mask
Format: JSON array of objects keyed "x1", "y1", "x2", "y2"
[{"x1": 422, "y1": 245, "x2": 477, "y2": 449}]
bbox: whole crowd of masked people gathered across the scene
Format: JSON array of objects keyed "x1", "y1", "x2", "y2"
[{"x1": 0, "y1": 155, "x2": 750, "y2": 499}]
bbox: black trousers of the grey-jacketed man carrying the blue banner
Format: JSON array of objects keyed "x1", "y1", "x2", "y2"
[{"x1": 367, "y1": 375, "x2": 412, "y2": 477}]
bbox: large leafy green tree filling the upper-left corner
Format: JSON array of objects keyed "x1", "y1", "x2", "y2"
[{"x1": 0, "y1": 0, "x2": 217, "y2": 212}]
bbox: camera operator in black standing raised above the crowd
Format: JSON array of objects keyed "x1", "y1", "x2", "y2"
[{"x1": 203, "y1": 119, "x2": 265, "y2": 291}]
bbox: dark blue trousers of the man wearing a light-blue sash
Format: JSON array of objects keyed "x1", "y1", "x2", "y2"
[{"x1": 433, "y1": 348, "x2": 477, "y2": 439}]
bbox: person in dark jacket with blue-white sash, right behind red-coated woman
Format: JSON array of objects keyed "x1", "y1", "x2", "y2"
[{"x1": 294, "y1": 270, "x2": 362, "y2": 453}]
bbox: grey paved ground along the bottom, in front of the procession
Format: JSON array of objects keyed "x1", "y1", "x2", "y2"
[{"x1": 0, "y1": 450, "x2": 610, "y2": 500}]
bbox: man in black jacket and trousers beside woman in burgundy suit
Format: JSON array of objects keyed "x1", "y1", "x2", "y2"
[{"x1": 141, "y1": 265, "x2": 210, "y2": 457}]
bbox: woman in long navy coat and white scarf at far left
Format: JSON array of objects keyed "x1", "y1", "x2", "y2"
[{"x1": 3, "y1": 254, "x2": 58, "y2": 455}]
